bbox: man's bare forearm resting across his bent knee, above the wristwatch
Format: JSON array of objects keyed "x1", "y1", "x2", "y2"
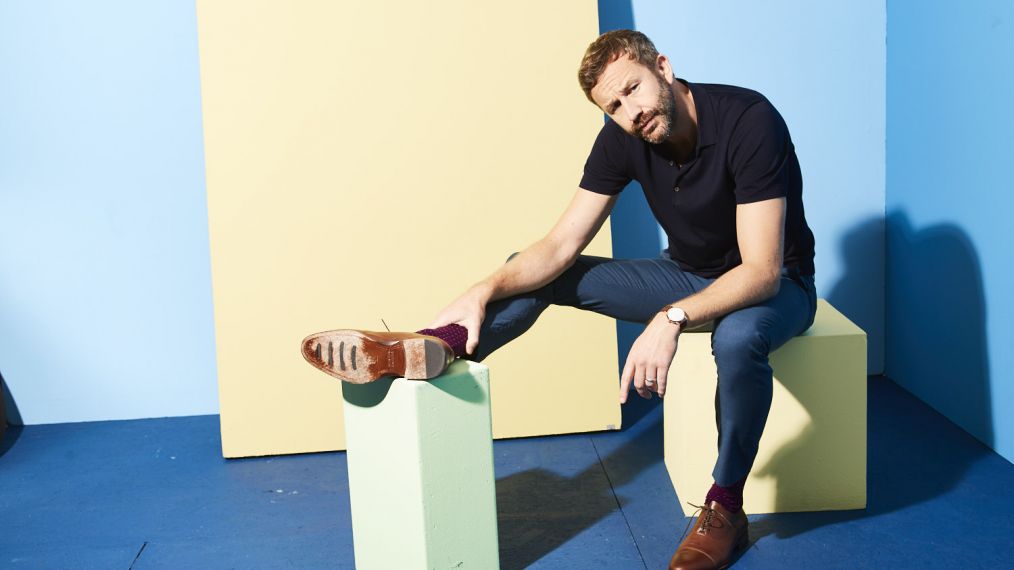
[{"x1": 659, "y1": 265, "x2": 781, "y2": 327}]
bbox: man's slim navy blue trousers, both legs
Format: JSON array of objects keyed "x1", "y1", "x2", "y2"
[{"x1": 473, "y1": 252, "x2": 816, "y2": 486}]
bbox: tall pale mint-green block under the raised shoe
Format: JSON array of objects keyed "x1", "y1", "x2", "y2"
[{"x1": 343, "y1": 360, "x2": 499, "y2": 569}]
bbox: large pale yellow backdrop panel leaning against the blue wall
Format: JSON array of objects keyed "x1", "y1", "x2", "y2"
[{"x1": 198, "y1": 0, "x2": 620, "y2": 456}]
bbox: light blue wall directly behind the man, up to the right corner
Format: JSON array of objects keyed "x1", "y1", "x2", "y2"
[{"x1": 598, "y1": 0, "x2": 886, "y2": 373}]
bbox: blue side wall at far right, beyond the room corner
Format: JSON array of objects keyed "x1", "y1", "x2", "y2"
[{"x1": 886, "y1": 0, "x2": 1014, "y2": 461}]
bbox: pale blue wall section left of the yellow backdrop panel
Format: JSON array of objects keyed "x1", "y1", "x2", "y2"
[{"x1": 0, "y1": 0, "x2": 218, "y2": 424}]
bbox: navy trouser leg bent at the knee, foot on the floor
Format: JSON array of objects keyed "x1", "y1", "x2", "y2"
[{"x1": 712, "y1": 273, "x2": 816, "y2": 488}]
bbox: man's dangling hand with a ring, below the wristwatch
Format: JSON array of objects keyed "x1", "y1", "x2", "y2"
[{"x1": 620, "y1": 312, "x2": 679, "y2": 404}]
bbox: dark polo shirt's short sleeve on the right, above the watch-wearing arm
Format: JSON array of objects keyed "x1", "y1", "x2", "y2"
[{"x1": 729, "y1": 99, "x2": 795, "y2": 204}]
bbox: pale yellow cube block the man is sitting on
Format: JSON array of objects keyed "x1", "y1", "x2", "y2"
[{"x1": 664, "y1": 299, "x2": 866, "y2": 515}]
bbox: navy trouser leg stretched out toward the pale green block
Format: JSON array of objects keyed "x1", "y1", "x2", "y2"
[{"x1": 472, "y1": 256, "x2": 711, "y2": 361}]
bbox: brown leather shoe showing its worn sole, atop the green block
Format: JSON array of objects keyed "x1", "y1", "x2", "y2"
[{"x1": 302, "y1": 330, "x2": 454, "y2": 384}]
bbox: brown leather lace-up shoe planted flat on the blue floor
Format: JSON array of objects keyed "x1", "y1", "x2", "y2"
[{"x1": 669, "y1": 501, "x2": 749, "y2": 570}]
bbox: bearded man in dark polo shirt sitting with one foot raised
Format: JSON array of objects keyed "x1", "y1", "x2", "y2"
[{"x1": 303, "y1": 30, "x2": 816, "y2": 569}]
